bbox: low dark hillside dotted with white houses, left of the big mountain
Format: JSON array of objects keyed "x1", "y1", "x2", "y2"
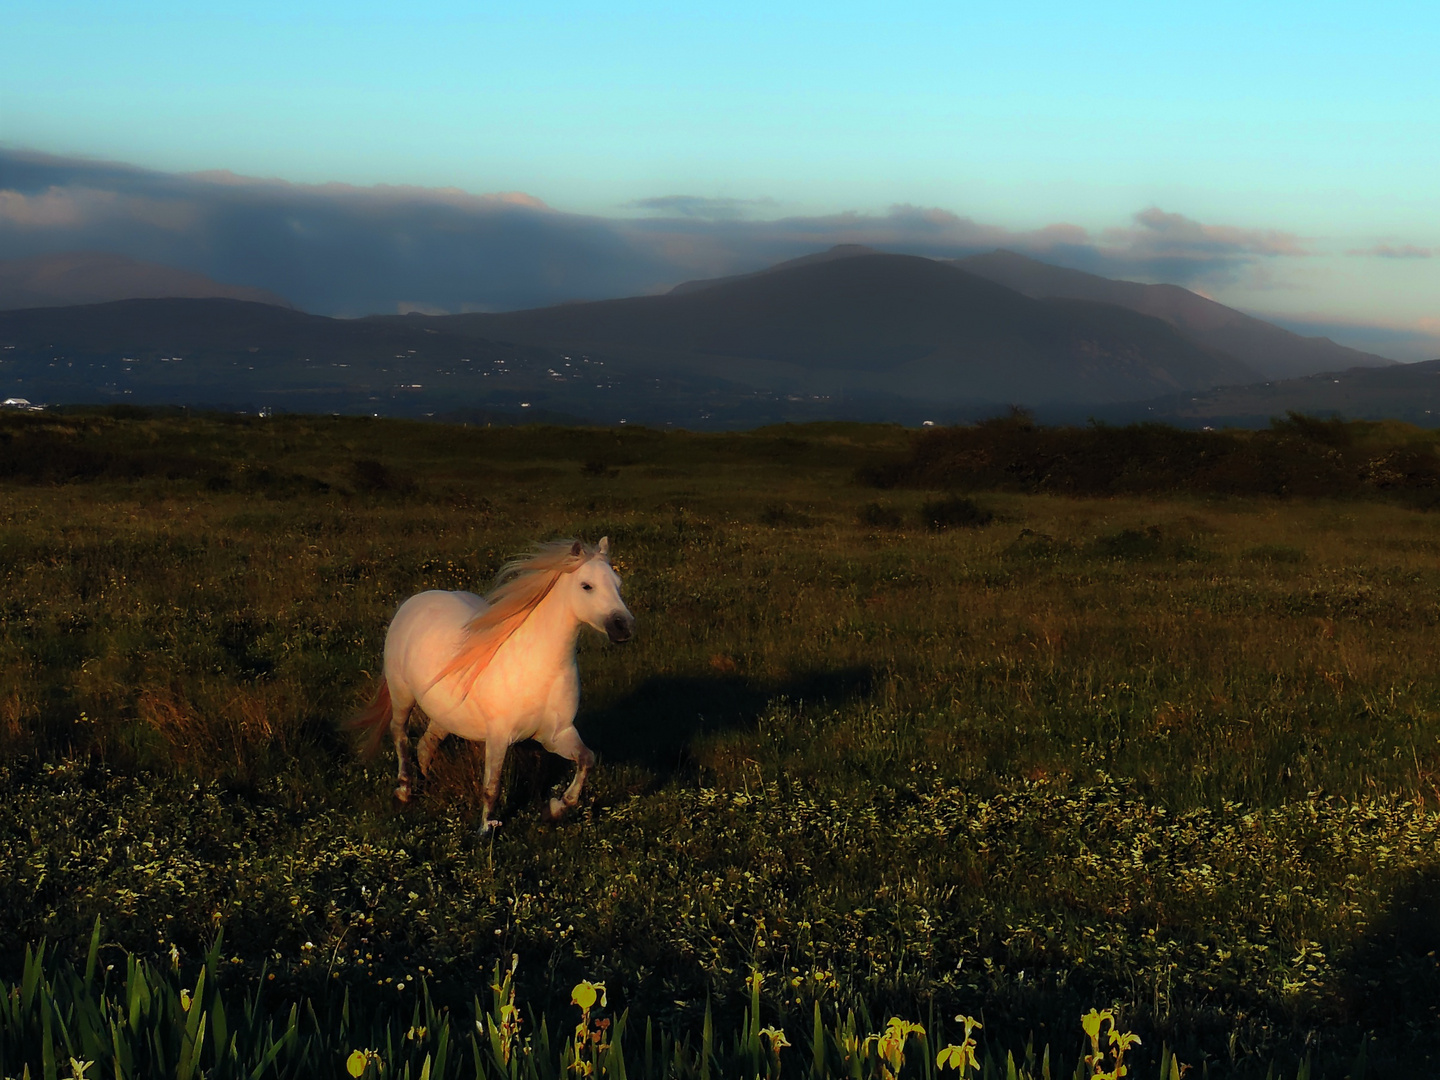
[{"x1": 0, "y1": 300, "x2": 766, "y2": 426}]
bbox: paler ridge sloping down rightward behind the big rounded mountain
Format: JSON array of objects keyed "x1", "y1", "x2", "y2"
[{"x1": 953, "y1": 251, "x2": 1395, "y2": 379}]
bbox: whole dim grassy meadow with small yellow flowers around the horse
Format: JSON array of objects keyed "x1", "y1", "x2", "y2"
[{"x1": 0, "y1": 410, "x2": 1440, "y2": 1077}]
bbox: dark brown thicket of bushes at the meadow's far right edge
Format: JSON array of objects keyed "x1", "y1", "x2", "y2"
[{"x1": 861, "y1": 409, "x2": 1440, "y2": 503}]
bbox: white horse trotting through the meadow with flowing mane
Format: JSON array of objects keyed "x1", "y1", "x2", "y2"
[{"x1": 351, "y1": 537, "x2": 635, "y2": 828}]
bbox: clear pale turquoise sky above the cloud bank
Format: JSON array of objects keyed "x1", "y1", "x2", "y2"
[{"x1": 0, "y1": 0, "x2": 1440, "y2": 355}]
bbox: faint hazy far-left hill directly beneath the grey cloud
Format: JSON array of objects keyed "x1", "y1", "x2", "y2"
[{"x1": 0, "y1": 252, "x2": 289, "y2": 311}]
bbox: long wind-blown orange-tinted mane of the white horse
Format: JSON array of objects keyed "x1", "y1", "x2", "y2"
[{"x1": 431, "y1": 540, "x2": 599, "y2": 697}]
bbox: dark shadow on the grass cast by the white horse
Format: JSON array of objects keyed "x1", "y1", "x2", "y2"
[{"x1": 576, "y1": 667, "x2": 876, "y2": 780}]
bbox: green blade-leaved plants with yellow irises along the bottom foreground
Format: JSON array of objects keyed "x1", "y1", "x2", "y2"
[{"x1": 0, "y1": 923, "x2": 1284, "y2": 1080}]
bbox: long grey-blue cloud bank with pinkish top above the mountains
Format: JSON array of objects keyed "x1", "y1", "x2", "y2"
[{"x1": 0, "y1": 150, "x2": 1309, "y2": 315}]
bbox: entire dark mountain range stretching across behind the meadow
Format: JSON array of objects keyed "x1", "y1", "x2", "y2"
[{"x1": 0, "y1": 246, "x2": 1416, "y2": 426}]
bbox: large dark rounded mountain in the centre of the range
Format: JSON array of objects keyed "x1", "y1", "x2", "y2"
[{"x1": 426, "y1": 253, "x2": 1259, "y2": 405}]
